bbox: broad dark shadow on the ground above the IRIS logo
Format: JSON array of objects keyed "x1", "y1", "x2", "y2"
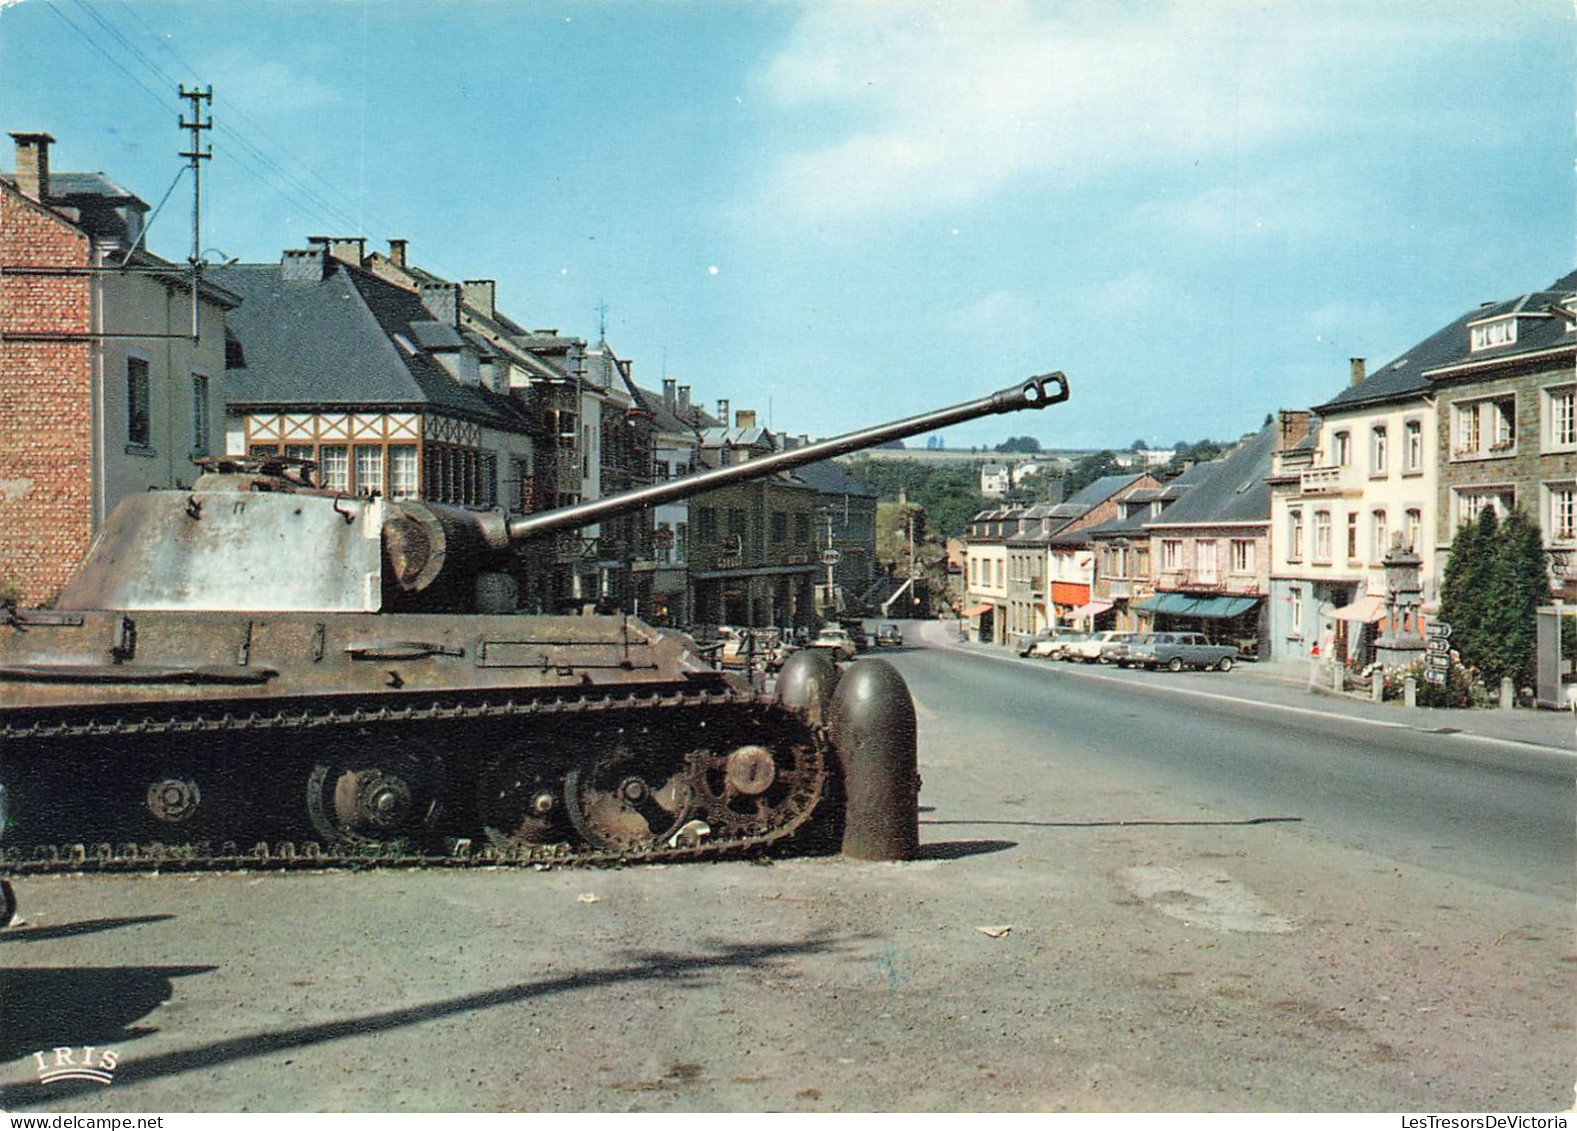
[{"x1": 0, "y1": 965, "x2": 218, "y2": 1066}]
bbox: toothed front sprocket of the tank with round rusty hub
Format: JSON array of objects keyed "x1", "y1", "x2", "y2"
[{"x1": 691, "y1": 741, "x2": 826, "y2": 839}]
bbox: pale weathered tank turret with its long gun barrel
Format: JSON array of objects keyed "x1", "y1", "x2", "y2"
[{"x1": 55, "y1": 372, "x2": 1068, "y2": 614}]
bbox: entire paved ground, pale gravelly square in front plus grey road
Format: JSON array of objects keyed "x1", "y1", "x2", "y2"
[{"x1": 0, "y1": 626, "x2": 1577, "y2": 1112}]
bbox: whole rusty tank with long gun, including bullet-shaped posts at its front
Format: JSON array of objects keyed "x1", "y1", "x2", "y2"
[{"x1": 0, "y1": 372, "x2": 1068, "y2": 872}]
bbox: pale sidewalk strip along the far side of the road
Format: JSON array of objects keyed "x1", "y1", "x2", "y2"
[{"x1": 921, "y1": 621, "x2": 1577, "y2": 760}]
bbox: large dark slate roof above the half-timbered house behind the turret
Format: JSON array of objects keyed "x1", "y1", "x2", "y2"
[{"x1": 208, "y1": 260, "x2": 533, "y2": 432}]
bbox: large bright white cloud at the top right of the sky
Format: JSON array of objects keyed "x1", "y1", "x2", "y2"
[{"x1": 757, "y1": 0, "x2": 1509, "y2": 224}]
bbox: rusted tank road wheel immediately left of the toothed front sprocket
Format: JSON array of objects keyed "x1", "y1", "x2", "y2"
[{"x1": 565, "y1": 737, "x2": 694, "y2": 852}]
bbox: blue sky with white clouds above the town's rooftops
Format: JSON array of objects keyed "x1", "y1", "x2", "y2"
[{"x1": 0, "y1": 0, "x2": 1577, "y2": 448}]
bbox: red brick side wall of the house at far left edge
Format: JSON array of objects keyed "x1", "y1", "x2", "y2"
[{"x1": 0, "y1": 185, "x2": 93, "y2": 604}]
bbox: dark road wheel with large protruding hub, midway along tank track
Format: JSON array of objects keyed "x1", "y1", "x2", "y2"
[{"x1": 306, "y1": 751, "x2": 445, "y2": 844}]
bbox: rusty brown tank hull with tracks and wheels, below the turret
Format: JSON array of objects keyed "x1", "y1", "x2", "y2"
[{"x1": 0, "y1": 610, "x2": 837, "y2": 871}]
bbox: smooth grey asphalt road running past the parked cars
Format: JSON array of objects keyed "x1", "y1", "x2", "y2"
[{"x1": 900, "y1": 626, "x2": 1577, "y2": 899}]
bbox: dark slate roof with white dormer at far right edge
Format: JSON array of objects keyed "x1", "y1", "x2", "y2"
[{"x1": 1315, "y1": 271, "x2": 1577, "y2": 415}]
